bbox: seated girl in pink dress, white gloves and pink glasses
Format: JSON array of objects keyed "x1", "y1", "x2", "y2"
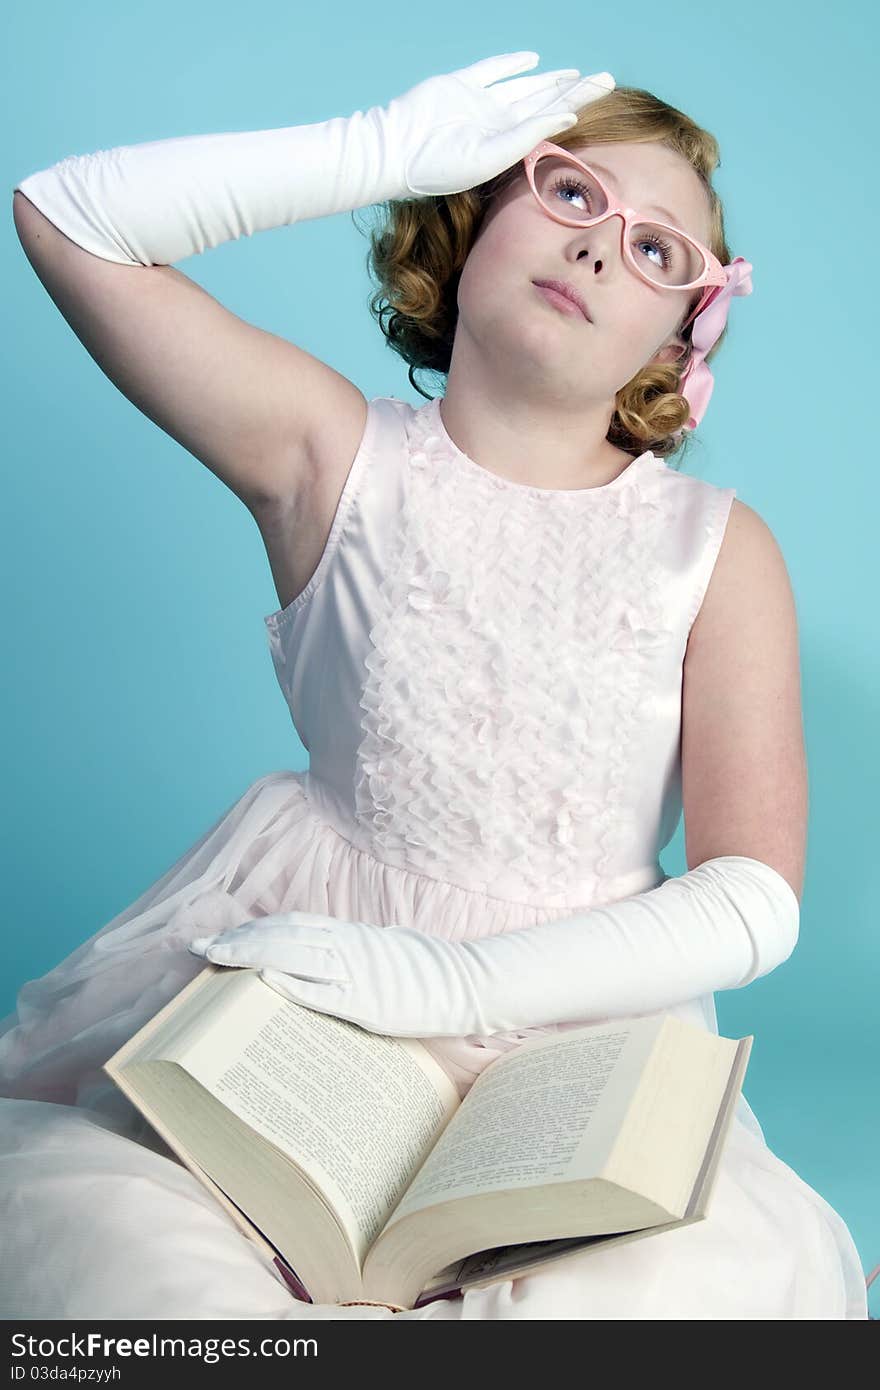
[{"x1": 0, "y1": 53, "x2": 866, "y2": 1321}]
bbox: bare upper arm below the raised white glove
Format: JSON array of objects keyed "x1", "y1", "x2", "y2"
[{"x1": 14, "y1": 192, "x2": 366, "y2": 517}]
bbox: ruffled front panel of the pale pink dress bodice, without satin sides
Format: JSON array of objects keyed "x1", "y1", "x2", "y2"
[{"x1": 356, "y1": 402, "x2": 676, "y2": 904}]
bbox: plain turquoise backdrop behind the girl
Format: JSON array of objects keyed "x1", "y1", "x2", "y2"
[{"x1": 0, "y1": 0, "x2": 880, "y2": 1312}]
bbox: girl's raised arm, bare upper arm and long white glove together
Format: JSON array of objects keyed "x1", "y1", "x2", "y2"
[{"x1": 13, "y1": 53, "x2": 613, "y2": 513}]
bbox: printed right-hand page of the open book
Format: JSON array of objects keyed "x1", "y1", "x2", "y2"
[{"x1": 388, "y1": 1019, "x2": 662, "y2": 1226}]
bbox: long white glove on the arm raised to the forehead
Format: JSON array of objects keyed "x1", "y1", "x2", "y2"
[{"x1": 15, "y1": 53, "x2": 614, "y2": 265}]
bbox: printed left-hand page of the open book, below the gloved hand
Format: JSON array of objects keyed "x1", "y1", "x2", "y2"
[{"x1": 178, "y1": 976, "x2": 460, "y2": 1264}]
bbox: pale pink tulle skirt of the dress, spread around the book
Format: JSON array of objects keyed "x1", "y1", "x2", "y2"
[{"x1": 0, "y1": 771, "x2": 867, "y2": 1321}]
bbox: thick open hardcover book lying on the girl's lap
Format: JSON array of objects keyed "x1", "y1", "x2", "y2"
[{"x1": 104, "y1": 963, "x2": 753, "y2": 1309}]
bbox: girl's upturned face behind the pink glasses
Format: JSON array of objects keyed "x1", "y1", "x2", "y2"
[{"x1": 453, "y1": 143, "x2": 709, "y2": 405}]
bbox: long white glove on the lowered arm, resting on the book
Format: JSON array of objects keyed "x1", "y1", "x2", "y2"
[{"x1": 189, "y1": 855, "x2": 801, "y2": 1037}]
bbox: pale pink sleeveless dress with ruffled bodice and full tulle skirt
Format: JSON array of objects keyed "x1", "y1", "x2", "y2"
[{"x1": 0, "y1": 396, "x2": 867, "y2": 1321}]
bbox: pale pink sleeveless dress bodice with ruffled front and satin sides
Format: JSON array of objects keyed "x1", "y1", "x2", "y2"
[{"x1": 264, "y1": 398, "x2": 734, "y2": 911}]
